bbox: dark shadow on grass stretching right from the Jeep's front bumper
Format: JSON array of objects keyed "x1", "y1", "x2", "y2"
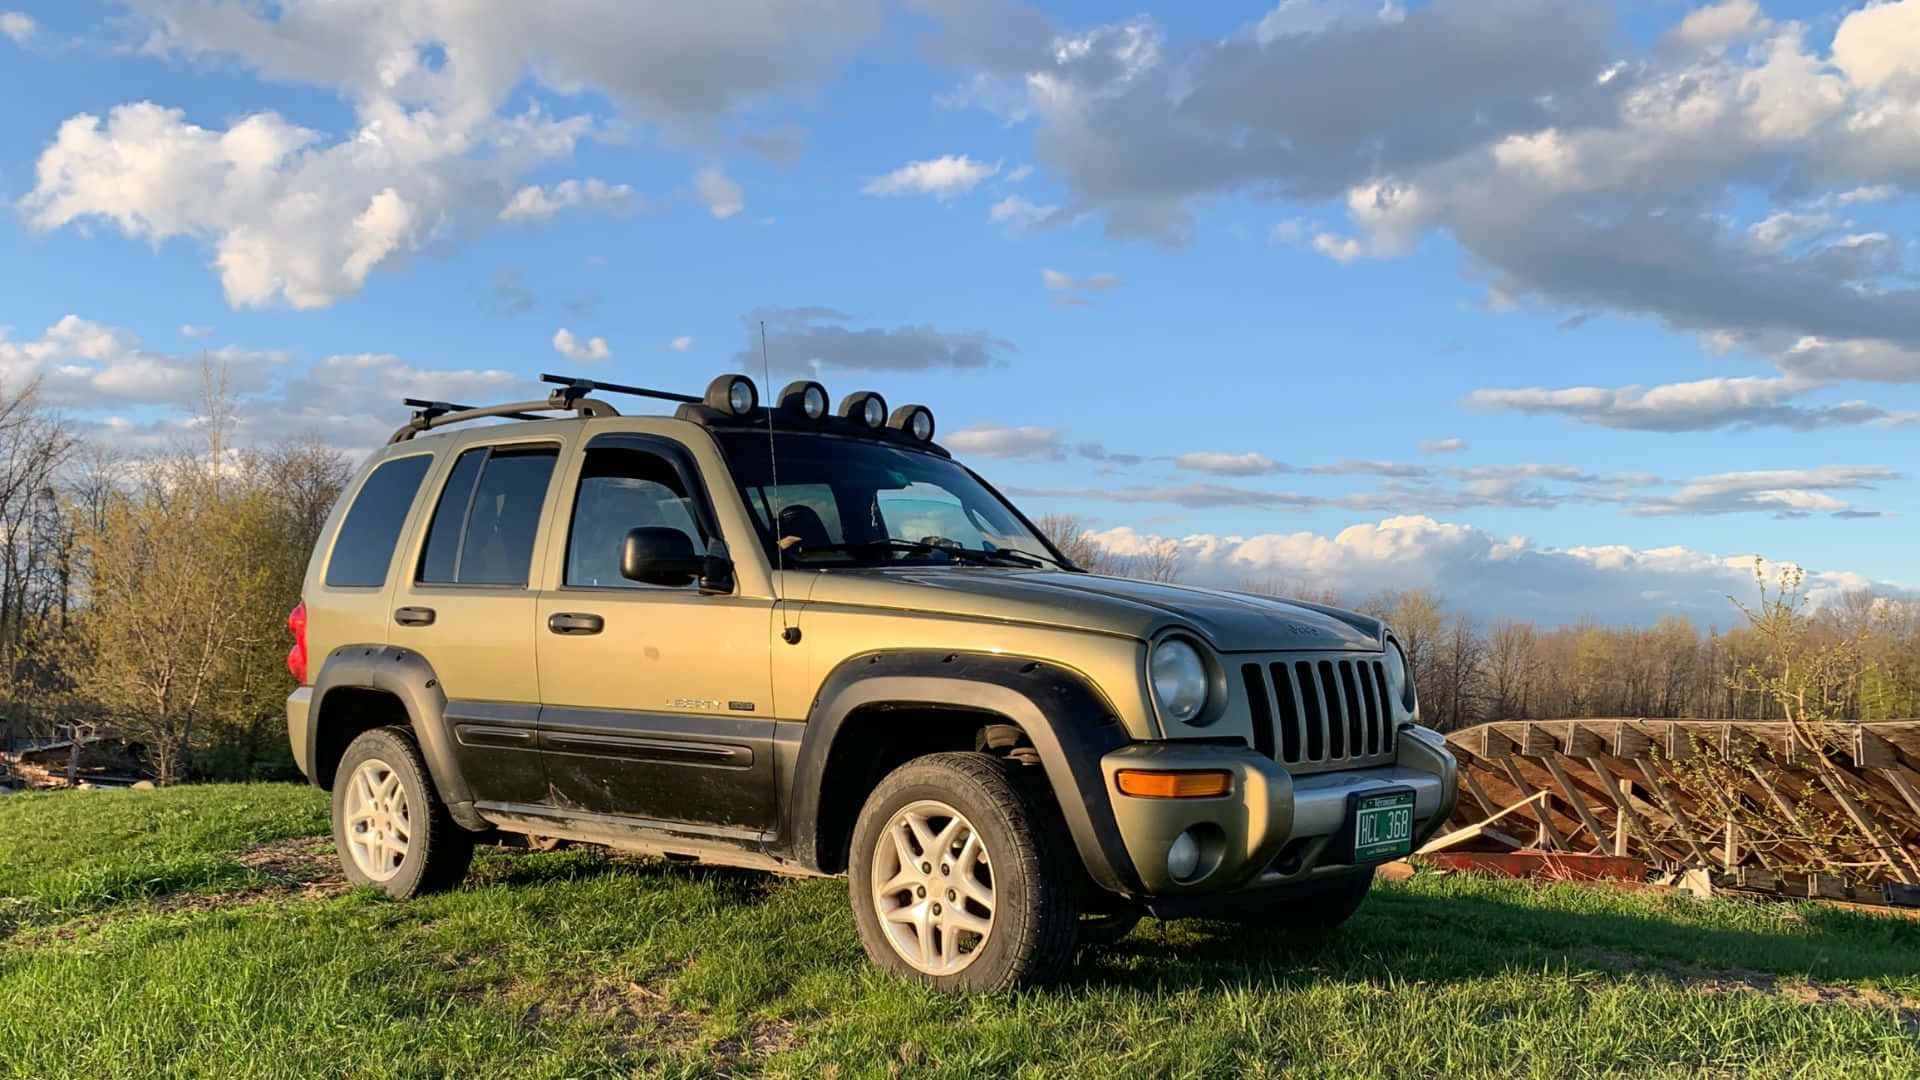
[{"x1": 1071, "y1": 876, "x2": 1920, "y2": 995}]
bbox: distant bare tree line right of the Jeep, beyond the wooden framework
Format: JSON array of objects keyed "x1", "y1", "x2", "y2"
[{"x1": 1037, "y1": 515, "x2": 1920, "y2": 730}]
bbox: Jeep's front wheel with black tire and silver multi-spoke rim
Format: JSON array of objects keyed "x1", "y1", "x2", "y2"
[{"x1": 847, "y1": 753, "x2": 1079, "y2": 994}]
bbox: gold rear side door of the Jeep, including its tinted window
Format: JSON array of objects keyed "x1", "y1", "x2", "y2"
[{"x1": 388, "y1": 438, "x2": 563, "y2": 803}]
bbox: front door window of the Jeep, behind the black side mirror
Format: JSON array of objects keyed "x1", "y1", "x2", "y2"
[{"x1": 566, "y1": 448, "x2": 707, "y2": 588}]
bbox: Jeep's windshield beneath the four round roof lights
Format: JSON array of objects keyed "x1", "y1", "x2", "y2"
[{"x1": 718, "y1": 430, "x2": 1058, "y2": 567}]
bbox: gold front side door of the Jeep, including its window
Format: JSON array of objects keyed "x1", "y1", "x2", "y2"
[{"x1": 534, "y1": 434, "x2": 776, "y2": 826}]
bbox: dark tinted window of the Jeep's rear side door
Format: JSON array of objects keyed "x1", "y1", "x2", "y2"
[{"x1": 408, "y1": 446, "x2": 559, "y2": 586}]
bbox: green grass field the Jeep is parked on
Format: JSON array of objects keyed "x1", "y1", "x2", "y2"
[{"x1": 0, "y1": 786, "x2": 1920, "y2": 1078}]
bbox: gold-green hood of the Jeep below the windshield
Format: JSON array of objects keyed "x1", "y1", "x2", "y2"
[{"x1": 806, "y1": 567, "x2": 1380, "y2": 651}]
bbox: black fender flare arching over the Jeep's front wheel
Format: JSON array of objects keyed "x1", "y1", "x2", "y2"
[{"x1": 787, "y1": 650, "x2": 1142, "y2": 896}]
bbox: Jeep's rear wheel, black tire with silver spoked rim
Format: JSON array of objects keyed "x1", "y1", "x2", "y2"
[{"x1": 334, "y1": 728, "x2": 474, "y2": 899}]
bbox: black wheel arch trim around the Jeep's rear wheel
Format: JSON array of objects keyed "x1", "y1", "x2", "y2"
[{"x1": 307, "y1": 646, "x2": 488, "y2": 830}]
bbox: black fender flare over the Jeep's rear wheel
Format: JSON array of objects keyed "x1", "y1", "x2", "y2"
[{"x1": 307, "y1": 646, "x2": 488, "y2": 828}]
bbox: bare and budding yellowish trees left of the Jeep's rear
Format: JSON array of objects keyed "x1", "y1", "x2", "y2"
[{"x1": 0, "y1": 379, "x2": 351, "y2": 784}]
